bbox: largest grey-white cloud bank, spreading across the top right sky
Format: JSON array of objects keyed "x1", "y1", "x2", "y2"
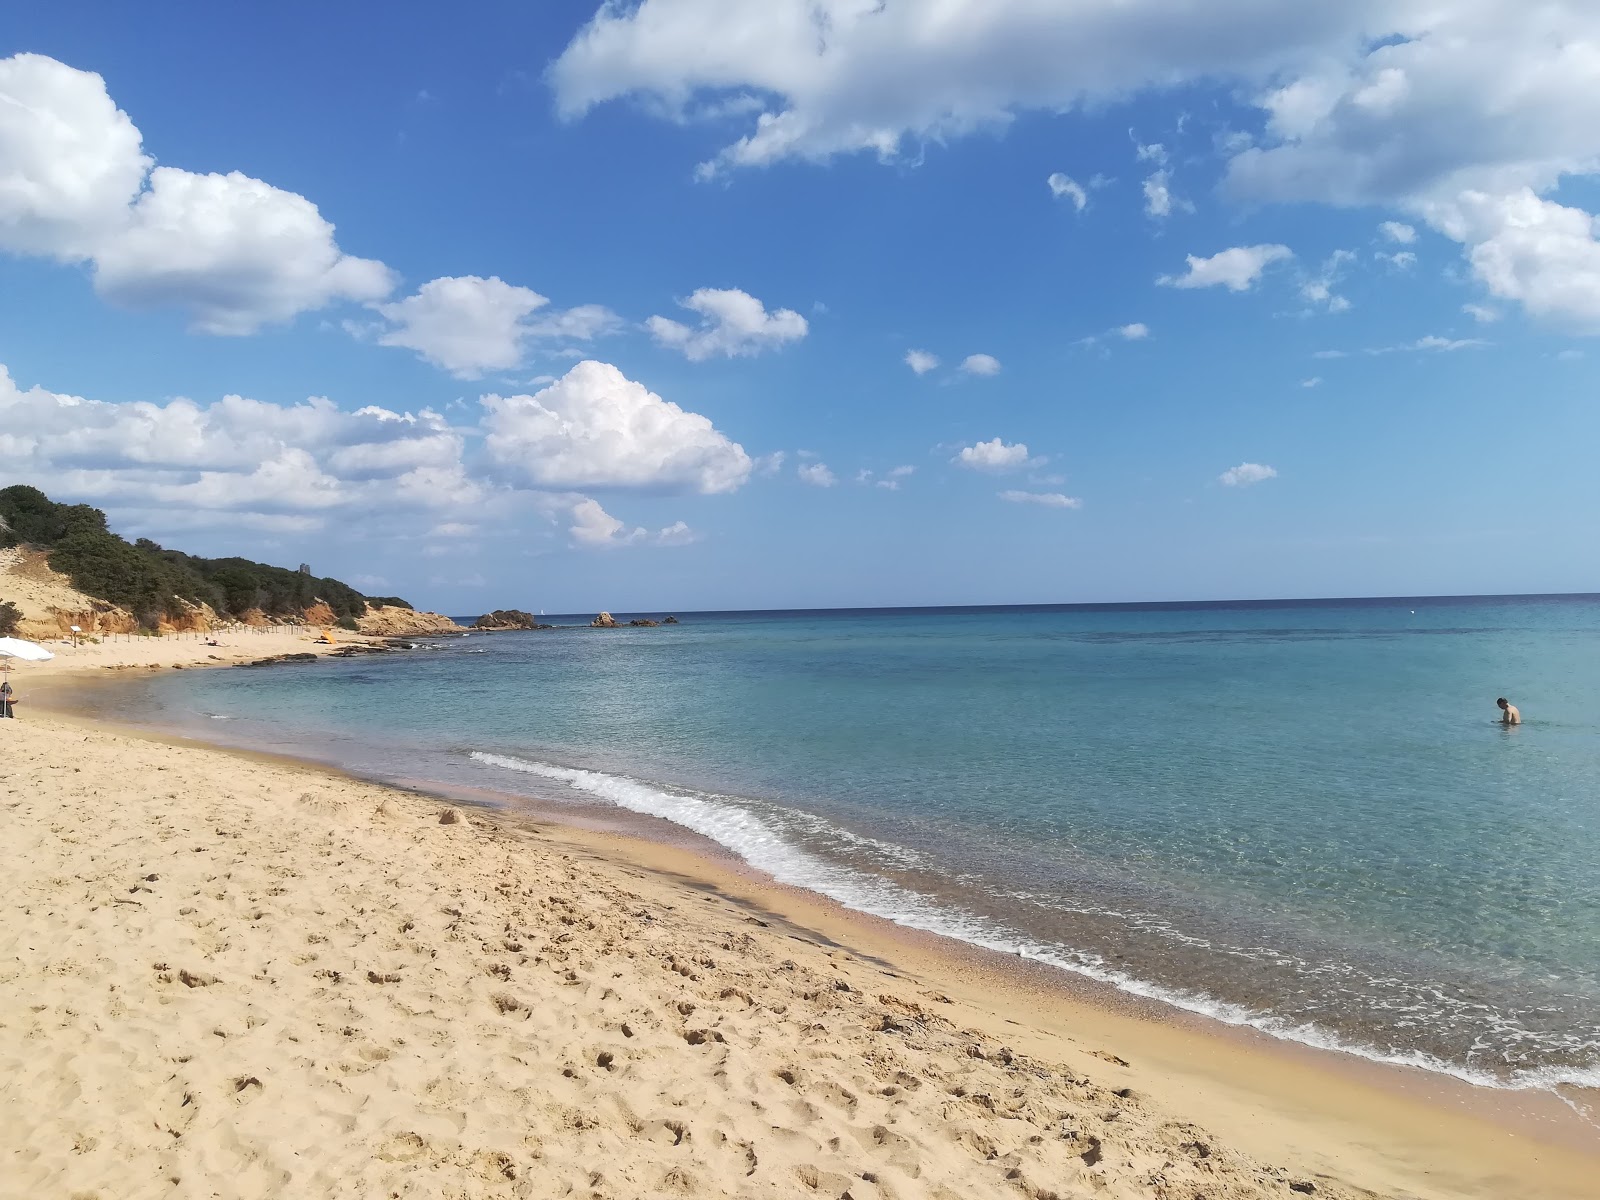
[{"x1": 547, "y1": 0, "x2": 1600, "y2": 331}]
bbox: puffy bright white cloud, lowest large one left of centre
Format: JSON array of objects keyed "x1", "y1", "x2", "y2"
[{"x1": 482, "y1": 360, "x2": 752, "y2": 494}]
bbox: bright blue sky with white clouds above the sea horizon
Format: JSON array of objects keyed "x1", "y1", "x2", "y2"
[{"x1": 0, "y1": 0, "x2": 1600, "y2": 613}]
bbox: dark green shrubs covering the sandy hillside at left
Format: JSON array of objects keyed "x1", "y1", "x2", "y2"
[{"x1": 0, "y1": 485, "x2": 411, "y2": 629}]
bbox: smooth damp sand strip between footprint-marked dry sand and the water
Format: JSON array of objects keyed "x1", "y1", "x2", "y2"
[{"x1": 12, "y1": 675, "x2": 1600, "y2": 1197}]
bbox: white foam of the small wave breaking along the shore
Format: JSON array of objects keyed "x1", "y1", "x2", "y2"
[{"x1": 469, "y1": 750, "x2": 1600, "y2": 1090}]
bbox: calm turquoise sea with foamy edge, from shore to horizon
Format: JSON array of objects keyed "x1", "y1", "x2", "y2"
[{"x1": 84, "y1": 597, "x2": 1600, "y2": 1086}]
